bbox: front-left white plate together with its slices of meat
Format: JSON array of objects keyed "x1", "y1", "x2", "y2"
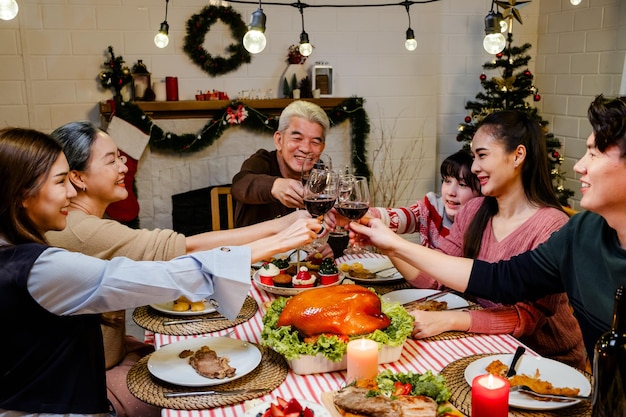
[{"x1": 148, "y1": 337, "x2": 261, "y2": 387}]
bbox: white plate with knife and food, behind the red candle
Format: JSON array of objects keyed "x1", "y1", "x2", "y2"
[{"x1": 465, "y1": 354, "x2": 591, "y2": 410}]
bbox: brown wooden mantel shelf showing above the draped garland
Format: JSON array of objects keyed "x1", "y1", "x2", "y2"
[{"x1": 100, "y1": 97, "x2": 347, "y2": 119}]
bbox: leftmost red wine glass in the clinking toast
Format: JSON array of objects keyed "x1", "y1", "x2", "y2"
[{"x1": 303, "y1": 168, "x2": 338, "y2": 252}]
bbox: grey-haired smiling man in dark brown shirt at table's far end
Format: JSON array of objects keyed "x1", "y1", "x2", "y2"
[{"x1": 231, "y1": 101, "x2": 330, "y2": 227}]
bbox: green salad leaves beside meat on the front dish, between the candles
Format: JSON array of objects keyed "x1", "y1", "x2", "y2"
[{"x1": 368, "y1": 369, "x2": 450, "y2": 403}]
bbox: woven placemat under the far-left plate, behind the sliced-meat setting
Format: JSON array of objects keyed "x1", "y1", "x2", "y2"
[{"x1": 133, "y1": 295, "x2": 259, "y2": 336}]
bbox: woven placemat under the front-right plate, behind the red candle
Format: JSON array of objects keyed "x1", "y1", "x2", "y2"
[{"x1": 441, "y1": 354, "x2": 591, "y2": 417}]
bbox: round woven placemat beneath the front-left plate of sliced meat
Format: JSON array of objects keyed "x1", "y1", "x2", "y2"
[{"x1": 126, "y1": 344, "x2": 289, "y2": 410}]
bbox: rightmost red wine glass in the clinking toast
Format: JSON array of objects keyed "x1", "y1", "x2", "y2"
[{"x1": 335, "y1": 175, "x2": 370, "y2": 255}]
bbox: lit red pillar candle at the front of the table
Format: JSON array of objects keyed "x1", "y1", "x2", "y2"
[{"x1": 472, "y1": 374, "x2": 511, "y2": 417}]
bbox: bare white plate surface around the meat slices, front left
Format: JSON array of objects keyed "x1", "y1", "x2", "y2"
[{"x1": 148, "y1": 337, "x2": 261, "y2": 387}]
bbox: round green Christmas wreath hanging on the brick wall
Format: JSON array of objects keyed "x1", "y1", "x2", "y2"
[{"x1": 183, "y1": 6, "x2": 250, "y2": 77}]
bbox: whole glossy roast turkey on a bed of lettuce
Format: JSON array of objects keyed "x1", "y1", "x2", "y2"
[{"x1": 277, "y1": 284, "x2": 391, "y2": 338}]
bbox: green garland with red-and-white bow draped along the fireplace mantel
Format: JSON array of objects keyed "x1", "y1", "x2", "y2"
[{"x1": 115, "y1": 97, "x2": 370, "y2": 178}]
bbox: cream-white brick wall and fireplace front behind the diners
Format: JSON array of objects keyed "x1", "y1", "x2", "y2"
[{"x1": 0, "y1": 0, "x2": 626, "y2": 227}]
